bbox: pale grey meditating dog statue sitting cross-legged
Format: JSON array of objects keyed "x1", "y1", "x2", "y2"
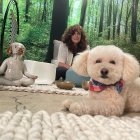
[{"x1": 0, "y1": 42, "x2": 37, "y2": 86}]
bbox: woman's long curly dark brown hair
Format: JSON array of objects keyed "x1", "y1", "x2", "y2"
[{"x1": 62, "y1": 24, "x2": 87, "y2": 55}]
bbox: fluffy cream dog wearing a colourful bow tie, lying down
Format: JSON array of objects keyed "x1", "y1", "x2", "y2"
[{"x1": 63, "y1": 45, "x2": 140, "y2": 116}]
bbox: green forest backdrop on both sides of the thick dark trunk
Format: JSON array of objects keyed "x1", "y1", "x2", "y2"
[{"x1": 0, "y1": 0, "x2": 140, "y2": 61}]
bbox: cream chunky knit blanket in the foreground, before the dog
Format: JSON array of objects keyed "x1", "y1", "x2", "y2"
[{"x1": 0, "y1": 110, "x2": 140, "y2": 140}]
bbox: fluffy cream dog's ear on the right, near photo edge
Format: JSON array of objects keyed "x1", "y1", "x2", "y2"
[{"x1": 123, "y1": 53, "x2": 140, "y2": 82}]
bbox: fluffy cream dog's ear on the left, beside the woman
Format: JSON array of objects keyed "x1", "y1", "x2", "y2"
[{"x1": 72, "y1": 50, "x2": 89, "y2": 76}]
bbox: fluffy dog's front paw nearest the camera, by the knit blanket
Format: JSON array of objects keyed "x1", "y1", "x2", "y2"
[{"x1": 69, "y1": 102, "x2": 84, "y2": 116}]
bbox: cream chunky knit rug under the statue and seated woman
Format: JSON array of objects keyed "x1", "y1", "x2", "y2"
[{"x1": 0, "y1": 84, "x2": 88, "y2": 95}]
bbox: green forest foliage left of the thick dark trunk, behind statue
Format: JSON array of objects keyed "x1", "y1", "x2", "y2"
[{"x1": 0, "y1": 0, "x2": 53, "y2": 61}]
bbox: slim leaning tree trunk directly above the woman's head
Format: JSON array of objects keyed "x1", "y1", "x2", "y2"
[{"x1": 80, "y1": 0, "x2": 87, "y2": 27}]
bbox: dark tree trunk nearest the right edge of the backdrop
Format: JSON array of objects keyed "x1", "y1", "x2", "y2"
[{"x1": 131, "y1": 0, "x2": 139, "y2": 43}]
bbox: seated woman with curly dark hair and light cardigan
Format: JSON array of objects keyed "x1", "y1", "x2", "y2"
[{"x1": 56, "y1": 25, "x2": 89, "y2": 86}]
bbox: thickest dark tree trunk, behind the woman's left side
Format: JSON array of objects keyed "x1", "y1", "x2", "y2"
[{"x1": 45, "y1": 0, "x2": 69, "y2": 62}]
